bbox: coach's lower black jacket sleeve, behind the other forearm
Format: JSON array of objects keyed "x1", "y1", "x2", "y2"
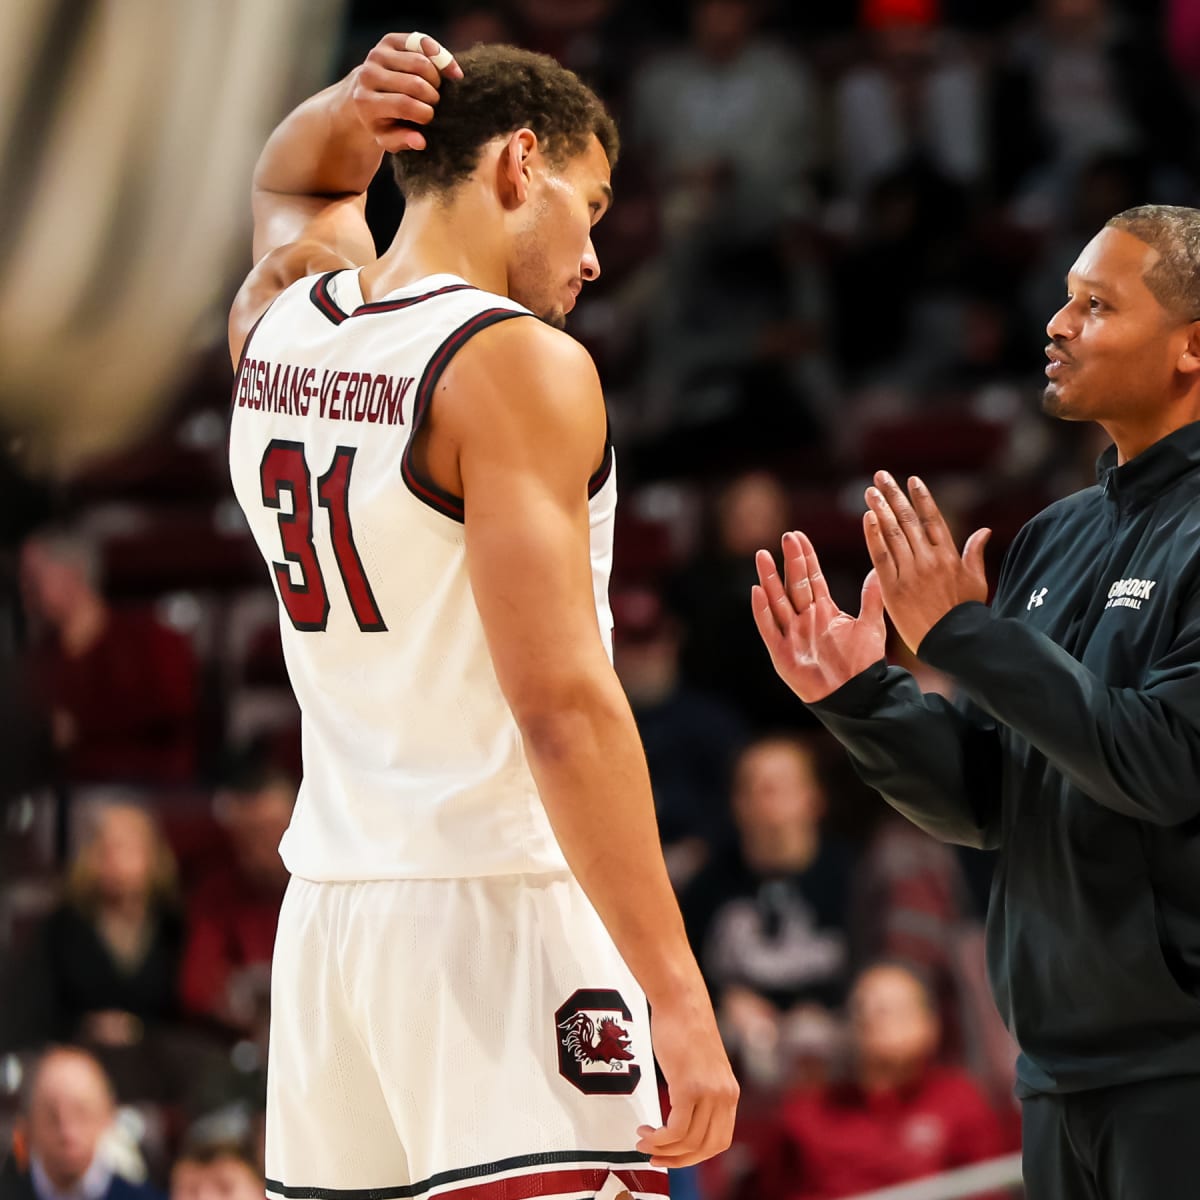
[{"x1": 809, "y1": 661, "x2": 1001, "y2": 848}]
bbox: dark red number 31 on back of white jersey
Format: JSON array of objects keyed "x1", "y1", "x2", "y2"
[{"x1": 259, "y1": 438, "x2": 388, "y2": 634}]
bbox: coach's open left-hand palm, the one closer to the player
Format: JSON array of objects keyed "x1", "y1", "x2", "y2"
[{"x1": 750, "y1": 533, "x2": 887, "y2": 703}]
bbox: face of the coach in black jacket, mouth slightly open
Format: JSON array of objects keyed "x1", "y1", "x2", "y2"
[{"x1": 1042, "y1": 228, "x2": 1192, "y2": 427}]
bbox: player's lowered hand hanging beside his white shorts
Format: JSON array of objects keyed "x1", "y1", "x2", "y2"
[{"x1": 637, "y1": 996, "x2": 738, "y2": 1166}]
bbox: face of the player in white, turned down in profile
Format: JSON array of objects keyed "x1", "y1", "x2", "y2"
[{"x1": 509, "y1": 137, "x2": 612, "y2": 329}]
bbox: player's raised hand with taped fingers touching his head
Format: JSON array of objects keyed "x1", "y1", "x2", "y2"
[{"x1": 353, "y1": 34, "x2": 462, "y2": 151}]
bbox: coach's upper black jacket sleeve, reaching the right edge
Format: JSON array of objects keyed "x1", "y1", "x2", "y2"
[{"x1": 919, "y1": 593, "x2": 1200, "y2": 826}]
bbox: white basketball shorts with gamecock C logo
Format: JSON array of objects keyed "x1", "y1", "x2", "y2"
[{"x1": 266, "y1": 872, "x2": 667, "y2": 1200}]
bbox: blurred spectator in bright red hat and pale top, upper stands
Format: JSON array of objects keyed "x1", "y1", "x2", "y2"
[{"x1": 833, "y1": 0, "x2": 988, "y2": 198}]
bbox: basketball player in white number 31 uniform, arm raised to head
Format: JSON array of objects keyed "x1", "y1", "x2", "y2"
[{"x1": 220, "y1": 35, "x2": 737, "y2": 1200}]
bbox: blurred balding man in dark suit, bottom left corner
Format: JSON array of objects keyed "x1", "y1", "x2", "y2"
[{"x1": 0, "y1": 1046, "x2": 160, "y2": 1200}]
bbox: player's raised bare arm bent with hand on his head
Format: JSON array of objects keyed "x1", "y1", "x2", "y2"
[{"x1": 229, "y1": 34, "x2": 462, "y2": 366}]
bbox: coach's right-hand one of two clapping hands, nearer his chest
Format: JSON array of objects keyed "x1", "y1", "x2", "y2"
[{"x1": 863, "y1": 470, "x2": 991, "y2": 654}]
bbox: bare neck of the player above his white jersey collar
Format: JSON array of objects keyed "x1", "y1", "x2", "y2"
[{"x1": 359, "y1": 188, "x2": 508, "y2": 301}]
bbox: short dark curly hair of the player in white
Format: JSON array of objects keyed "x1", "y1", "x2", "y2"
[{"x1": 391, "y1": 46, "x2": 620, "y2": 199}]
